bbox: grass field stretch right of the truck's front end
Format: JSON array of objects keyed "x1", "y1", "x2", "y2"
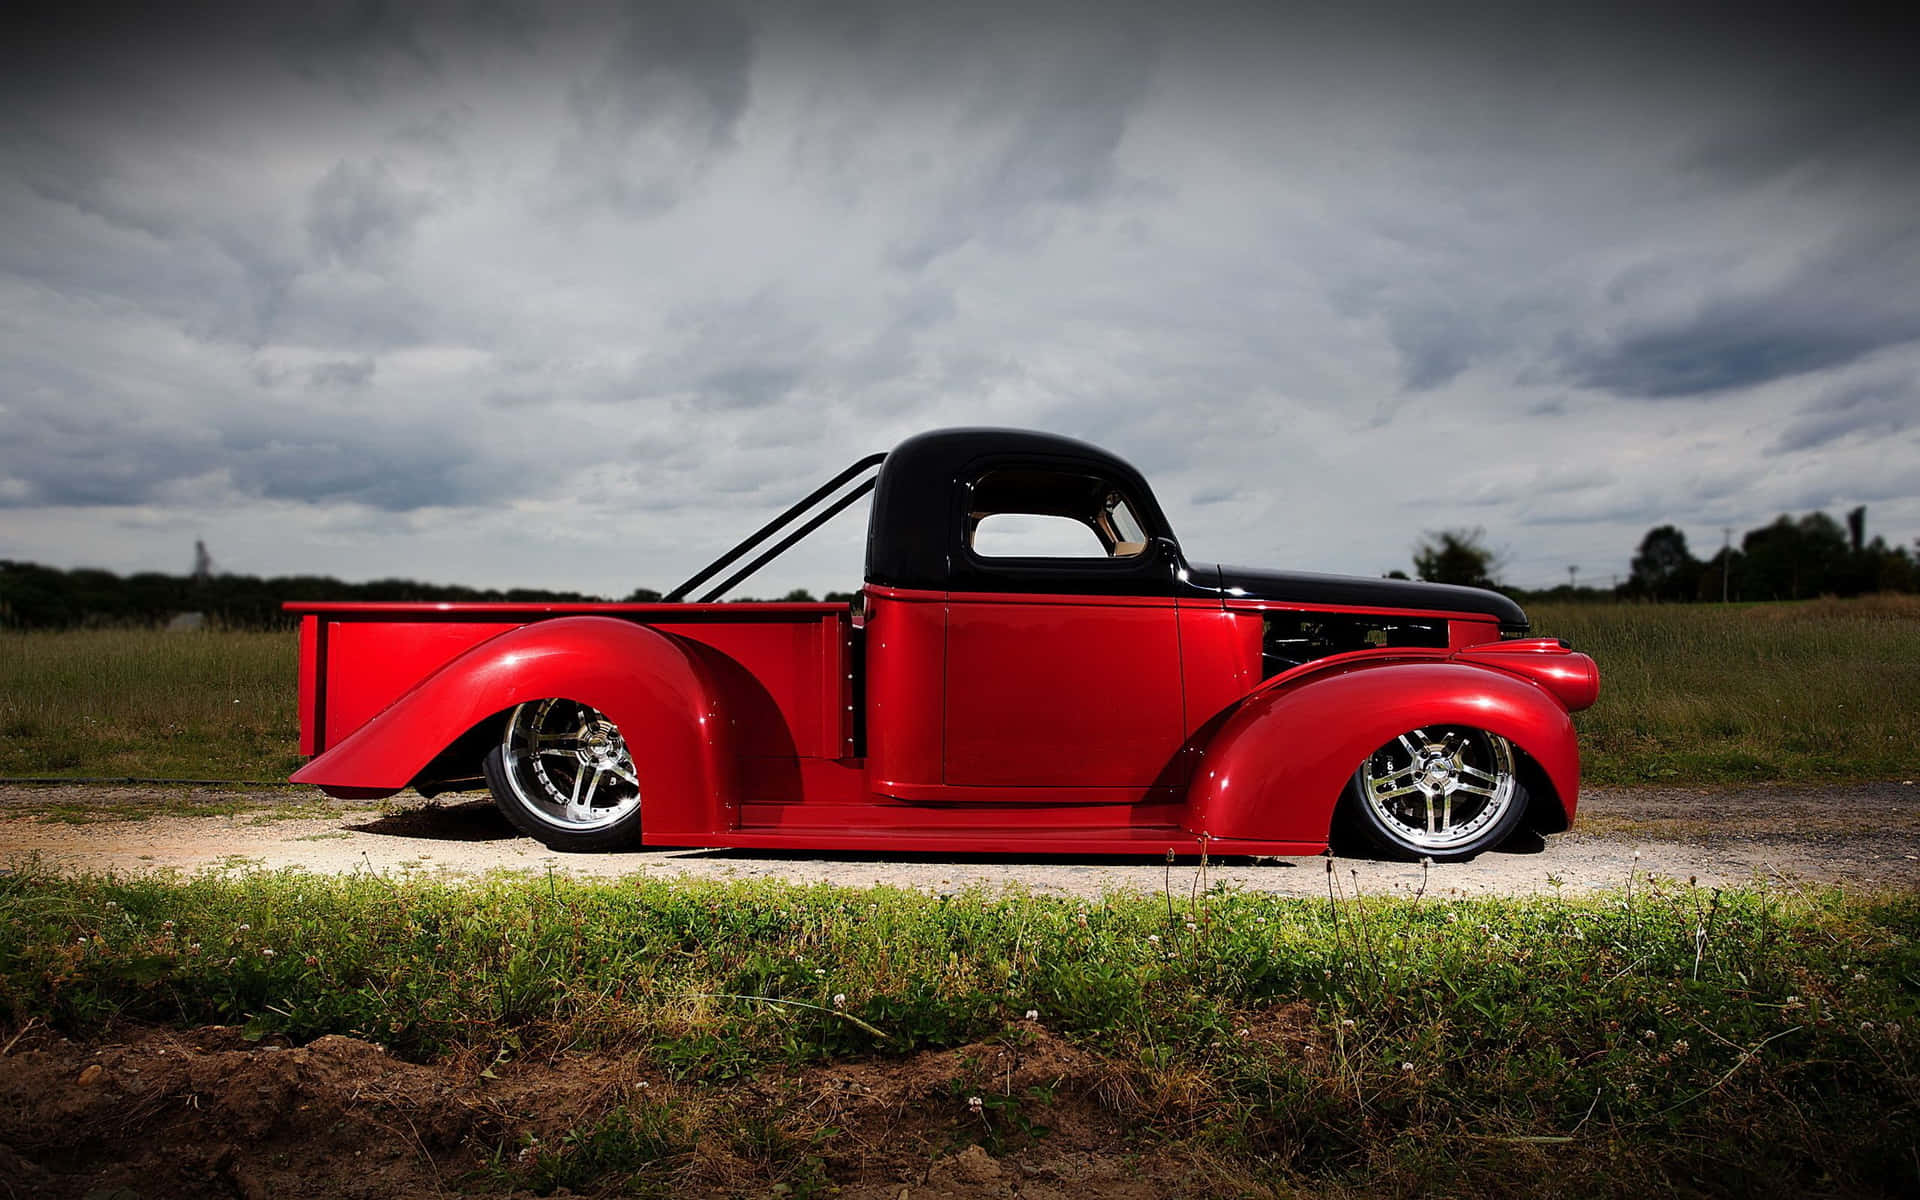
[{"x1": 1528, "y1": 595, "x2": 1920, "y2": 783}]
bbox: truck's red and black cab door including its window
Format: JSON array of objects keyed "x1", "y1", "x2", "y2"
[{"x1": 945, "y1": 465, "x2": 1185, "y2": 799}]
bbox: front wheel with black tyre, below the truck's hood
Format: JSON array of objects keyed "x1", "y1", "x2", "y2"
[{"x1": 1348, "y1": 726, "x2": 1528, "y2": 862}]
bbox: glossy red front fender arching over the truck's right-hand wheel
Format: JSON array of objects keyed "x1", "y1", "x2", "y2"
[{"x1": 1188, "y1": 659, "x2": 1580, "y2": 845}]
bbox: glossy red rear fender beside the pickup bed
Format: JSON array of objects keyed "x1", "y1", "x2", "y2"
[{"x1": 292, "y1": 616, "x2": 737, "y2": 841}]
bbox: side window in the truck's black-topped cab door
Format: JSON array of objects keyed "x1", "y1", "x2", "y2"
[{"x1": 968, "y1": 468, "x2": 1146, "y2": 559}]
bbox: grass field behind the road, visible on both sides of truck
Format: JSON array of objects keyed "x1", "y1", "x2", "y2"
[{"x1": 0, "y1": 597, "x2": 1920, "y2": 783}]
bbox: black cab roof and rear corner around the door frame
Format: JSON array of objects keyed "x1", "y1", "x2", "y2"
[{"x1": 866, "y1": 428, "x2": 1173, "y2": 589}]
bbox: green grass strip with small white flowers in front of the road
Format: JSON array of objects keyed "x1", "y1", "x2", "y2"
[{"x1": 0, "y1": 864, "x2": 1920, "y2": 1194}]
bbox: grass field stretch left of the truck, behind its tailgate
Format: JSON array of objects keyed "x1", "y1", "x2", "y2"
[{"x1": 0, "y1": 630, "x2": 301, "y2": 780}]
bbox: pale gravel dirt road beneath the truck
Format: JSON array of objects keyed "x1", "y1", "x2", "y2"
[{"x1": 0, "y1": 780, "x2": 1920, "y2": 895}]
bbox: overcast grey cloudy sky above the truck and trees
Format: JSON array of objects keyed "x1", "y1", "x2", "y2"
[{"x1": 0, "y1": 0, "x2": 1920, "y2": 595}]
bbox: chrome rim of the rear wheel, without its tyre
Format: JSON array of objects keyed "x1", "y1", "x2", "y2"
[{"x1": 501, "y1": 699, "x2": 639, "y2": 833}]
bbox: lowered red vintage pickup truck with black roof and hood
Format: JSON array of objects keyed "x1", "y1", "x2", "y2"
[{"x1": 288, "y1": 428, "x2": 1599, "y2": 860}]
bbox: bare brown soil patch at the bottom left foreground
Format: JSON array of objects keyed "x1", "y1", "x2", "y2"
[{"x1": 0, "y1": 1027, "x2": 1212, "y2": 1200}]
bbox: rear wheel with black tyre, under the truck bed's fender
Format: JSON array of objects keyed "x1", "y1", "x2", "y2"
[{"x1": 482, "y1": 699, "x2": 639, "y2": 851}]
